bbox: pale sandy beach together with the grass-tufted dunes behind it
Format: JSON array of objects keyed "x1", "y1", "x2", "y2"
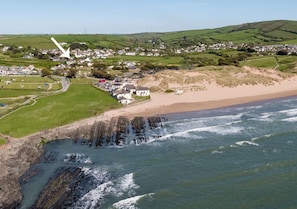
[{"x1": 99, "y1": 67, "x2": 297, "y2": 117}]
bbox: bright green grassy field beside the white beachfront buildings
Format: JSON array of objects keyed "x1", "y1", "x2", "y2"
[{"x1": 0, "y1": 84, "x2": 121, "y2": 137}]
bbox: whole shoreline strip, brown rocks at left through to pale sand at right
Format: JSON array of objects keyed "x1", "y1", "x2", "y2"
[{"x1": 0, "y1": 69, "x2": 297, "y2": 208}]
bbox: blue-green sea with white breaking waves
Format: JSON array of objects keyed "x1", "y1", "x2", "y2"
[{"x1": 21, "y1": 97, "x2": 297, "y2": 209}]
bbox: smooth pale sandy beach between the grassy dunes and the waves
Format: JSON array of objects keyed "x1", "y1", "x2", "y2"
[{"x1": 104, "y1": 79, "x2": 297, "y2": 117}]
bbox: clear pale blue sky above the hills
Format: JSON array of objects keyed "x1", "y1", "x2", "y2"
[{"x1": 0, "y1": 0, "x2": 297, "y2": 34}]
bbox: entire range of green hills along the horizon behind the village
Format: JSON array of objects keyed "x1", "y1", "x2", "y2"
[{"x1": 0, "y1": 20, "x2": 297, "y2": 49}]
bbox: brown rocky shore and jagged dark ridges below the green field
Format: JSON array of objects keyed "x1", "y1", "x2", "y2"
[{"x1": 0, "y1": 117, "x2": 164, "y2": 209}]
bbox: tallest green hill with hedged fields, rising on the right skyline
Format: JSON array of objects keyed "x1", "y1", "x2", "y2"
[{"x1": 153, "y1": 20, "x2": 297, "y2": 45}]
